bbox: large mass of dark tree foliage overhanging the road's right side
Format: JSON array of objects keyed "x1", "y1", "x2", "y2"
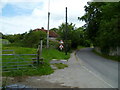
[{"x1": 78, "y1": 2, "x2": 120, "y2": 54}]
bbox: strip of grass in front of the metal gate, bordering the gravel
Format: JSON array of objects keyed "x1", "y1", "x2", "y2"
[{"x1": 3, "y1": 63, "x2": 54, "y2": 77}]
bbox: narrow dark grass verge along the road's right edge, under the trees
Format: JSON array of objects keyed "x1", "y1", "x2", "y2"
[{"x1": 93, "y1": 49, "x2": 120, "y2": 62}]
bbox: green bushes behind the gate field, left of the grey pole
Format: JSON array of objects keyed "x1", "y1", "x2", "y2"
[{"x1": 3, "y1": 30, "x2": 46, "y2": 47}]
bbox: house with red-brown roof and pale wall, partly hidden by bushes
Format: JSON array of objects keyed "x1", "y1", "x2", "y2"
[{"x1": 33, "y1": 27, "x2": 58, "y2": 40}]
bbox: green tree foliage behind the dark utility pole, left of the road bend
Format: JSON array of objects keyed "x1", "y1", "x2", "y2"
[{"x1": 52, "y1": 23, "x2": 89, "y2": 51}]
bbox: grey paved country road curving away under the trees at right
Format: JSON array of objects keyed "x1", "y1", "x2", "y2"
[{"x1": 76, "y1": 48, "x2": 118, "y2": 88}]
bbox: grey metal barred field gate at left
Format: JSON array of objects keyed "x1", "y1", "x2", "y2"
[{"x1": 2, "y1": 50, "x2": 37, "y2": 72}]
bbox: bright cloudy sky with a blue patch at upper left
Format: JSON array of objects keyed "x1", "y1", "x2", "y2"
[{"x1": 0, "y1": 0, "x2": 90, "y2": 34}]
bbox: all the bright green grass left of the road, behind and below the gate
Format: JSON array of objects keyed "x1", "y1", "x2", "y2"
[{"x1": 2, "y1": 46, "x2": 70, "y2": 76}]
